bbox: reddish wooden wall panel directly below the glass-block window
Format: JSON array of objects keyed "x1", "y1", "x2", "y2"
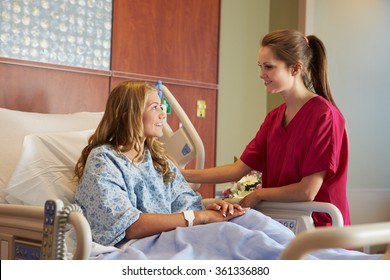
[{"x1": 0, "y1": 57, "x2": 110, "y2": 113}]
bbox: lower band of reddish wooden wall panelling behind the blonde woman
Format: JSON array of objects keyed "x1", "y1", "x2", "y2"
[{"x1": 0, "y1": 57, "x2": 216, "y2": 197}]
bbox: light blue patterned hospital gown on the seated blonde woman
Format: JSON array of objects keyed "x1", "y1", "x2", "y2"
[{"x1": 76, "y1": 145, "x2": 203, "y2": 245}]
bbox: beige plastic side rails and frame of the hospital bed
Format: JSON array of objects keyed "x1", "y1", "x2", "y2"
[{"x1": 0, "y1": 86, "x2": 390, "y2": 260}]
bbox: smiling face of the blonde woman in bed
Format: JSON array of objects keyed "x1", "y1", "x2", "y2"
[{"x1": 142, "y1": 91, "x2": 165, "y2": 137}]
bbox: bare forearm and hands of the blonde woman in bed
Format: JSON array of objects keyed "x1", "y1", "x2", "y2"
[{"x1": 126, "y1": 200, "x2": 246, "y2": 240}]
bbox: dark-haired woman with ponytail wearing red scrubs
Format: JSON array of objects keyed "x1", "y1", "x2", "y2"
[{"x1": 182, "y1": 30, "x2": 350, "y2": 229}]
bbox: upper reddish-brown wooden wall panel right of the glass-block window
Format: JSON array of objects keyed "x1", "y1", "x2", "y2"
[{"x1": 112, "y1": 0, "x2": 219, "y2": 84}]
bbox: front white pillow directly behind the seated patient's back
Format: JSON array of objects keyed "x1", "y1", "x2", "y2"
[{"x1": 5, "y1": 130, "x2": 94, "y2": 206}]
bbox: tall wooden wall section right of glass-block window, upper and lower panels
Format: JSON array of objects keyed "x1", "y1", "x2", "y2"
[{"x1": 111, "y1": 0, "x2": 220, "y2": 197}]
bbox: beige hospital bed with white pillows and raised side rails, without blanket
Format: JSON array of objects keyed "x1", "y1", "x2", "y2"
[{"x1": 0, "y1": 83, "x2": 390, "y2": 259}]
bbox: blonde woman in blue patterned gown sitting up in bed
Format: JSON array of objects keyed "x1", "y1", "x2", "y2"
[{"x1": 75, "y1": 81, "x2": 294, "y2": 258}]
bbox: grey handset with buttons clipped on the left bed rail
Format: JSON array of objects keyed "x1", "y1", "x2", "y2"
[{"x1": 41, "y1": 200, "x2": 64, "y2": 260}]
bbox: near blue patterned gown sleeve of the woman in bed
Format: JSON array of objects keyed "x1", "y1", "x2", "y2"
[{"x1": 76, "y1": 153, "x2": 140, "y2": 245}]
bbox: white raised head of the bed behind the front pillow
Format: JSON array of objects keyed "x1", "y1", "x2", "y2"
[{"x1": 0, "y1": 108, "x2": 103, "y2": 203}]
